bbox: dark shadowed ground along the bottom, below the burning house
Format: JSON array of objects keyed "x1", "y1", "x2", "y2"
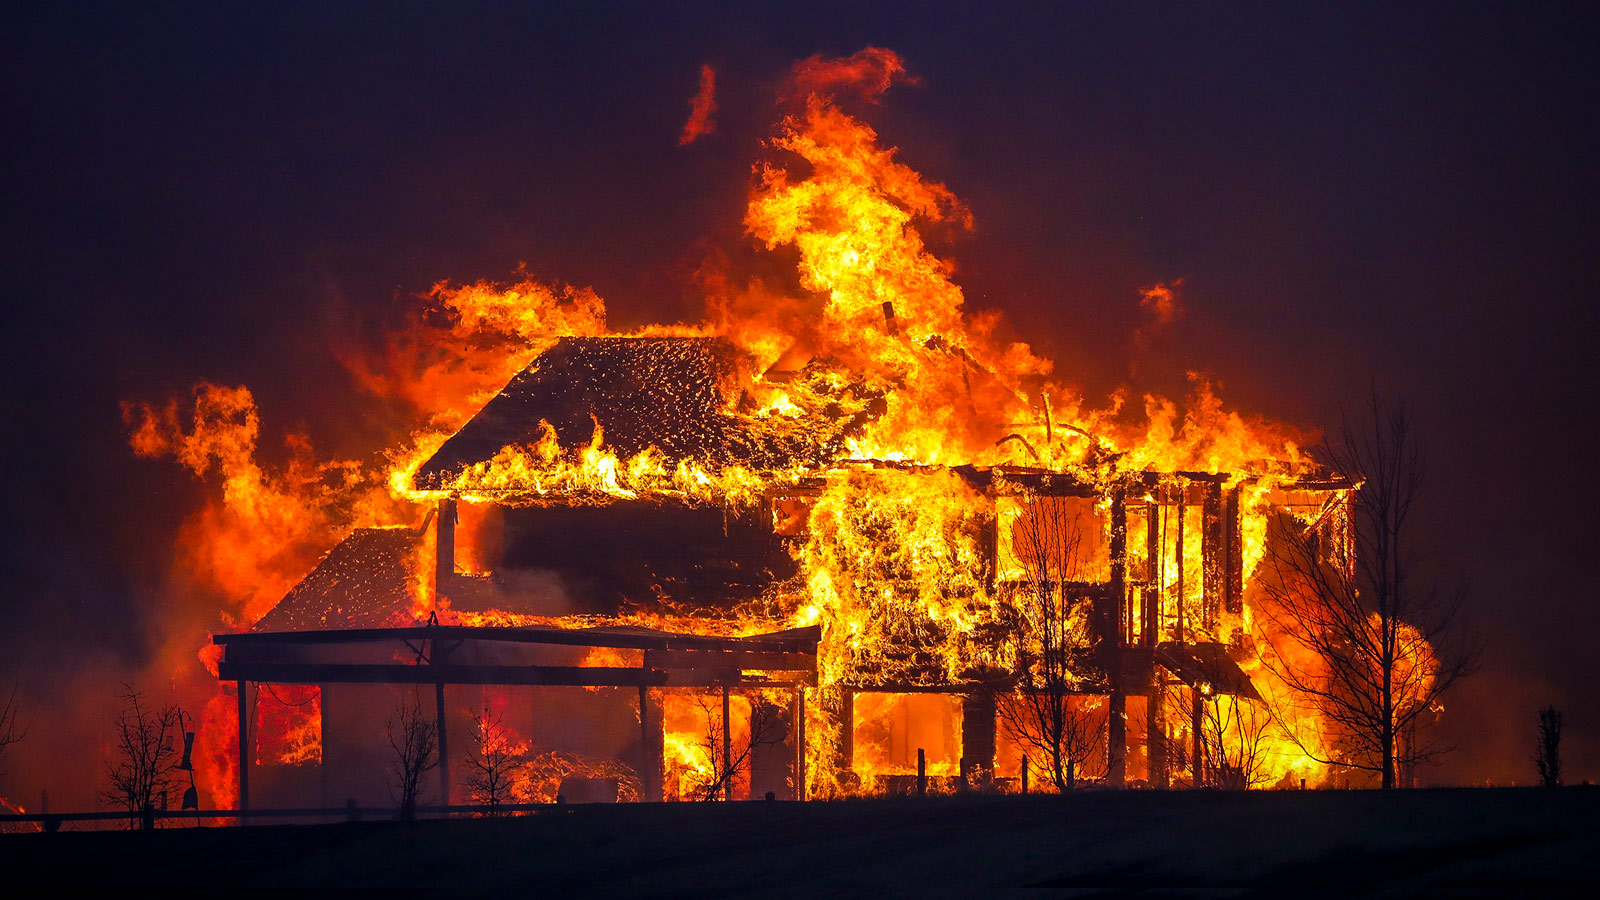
[{"x1": 0, "y1": 788, "x2": 1600, "y2": 897}]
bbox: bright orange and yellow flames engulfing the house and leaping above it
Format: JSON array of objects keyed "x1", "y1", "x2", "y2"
[{"x1": 125, "y1": 48, "x2": 1426, "y2": 799}]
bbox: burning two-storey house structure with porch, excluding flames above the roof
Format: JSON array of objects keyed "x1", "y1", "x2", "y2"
[{"x1": 216, "y1": 328, "x2": 1350, "y2": 802}]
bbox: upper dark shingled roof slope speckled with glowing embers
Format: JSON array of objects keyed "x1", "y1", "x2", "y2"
[{"x1": 414, "y1": 338, "x2": 837, "y2": 490}]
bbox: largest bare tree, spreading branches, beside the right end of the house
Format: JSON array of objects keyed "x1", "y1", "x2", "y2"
[{"x1": 1261, "y1": 394, "x2": 1480, "y2": 788}]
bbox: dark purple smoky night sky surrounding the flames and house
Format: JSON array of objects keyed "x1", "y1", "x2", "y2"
[{"x1": 0, "y1": 3, "x2": 1600, "y2": 783}]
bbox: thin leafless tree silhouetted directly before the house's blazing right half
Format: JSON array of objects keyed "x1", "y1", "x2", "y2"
[{"x1": 995, "y1": 486, "x2": 1106, "y2": 791}]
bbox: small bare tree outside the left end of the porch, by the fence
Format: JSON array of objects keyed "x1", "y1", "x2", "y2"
[{"x1": 101, "y1": 682, "x2": 182, "y2": 828}]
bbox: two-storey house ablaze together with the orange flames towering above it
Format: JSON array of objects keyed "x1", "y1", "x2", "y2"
[{"x1": 130, "y1": 50, "x2": 1452, "y2": 806}]
